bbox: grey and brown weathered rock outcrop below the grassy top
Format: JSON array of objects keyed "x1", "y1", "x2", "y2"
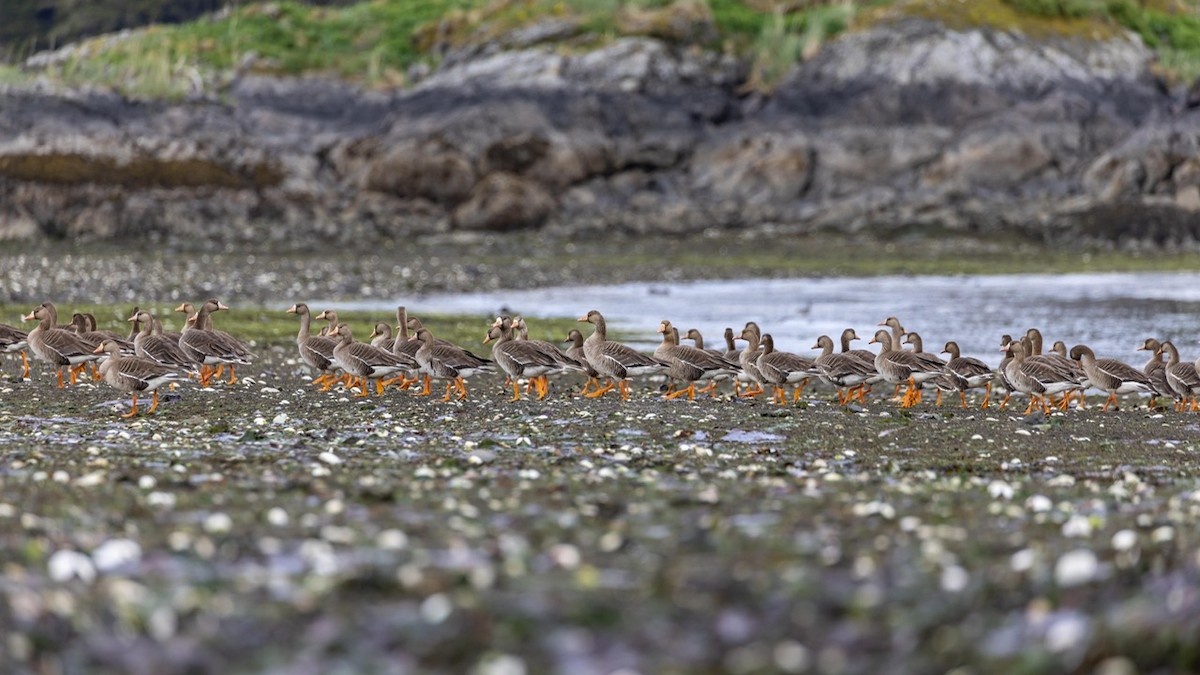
[{"x1": 0, "y1": 19, "x2": 1200, "y2": 247}]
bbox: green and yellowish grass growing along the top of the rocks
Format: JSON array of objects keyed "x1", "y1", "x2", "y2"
[{"x1": 9, "y1": 0, "x2": 1200, "y2": 98}]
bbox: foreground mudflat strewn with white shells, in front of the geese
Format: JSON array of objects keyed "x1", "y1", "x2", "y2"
[{"x1": 0, "y1": 346, "x2": 1200, "y2": 673}]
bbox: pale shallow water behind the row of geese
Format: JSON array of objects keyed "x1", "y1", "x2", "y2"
[{"x1": 322, "y1": 273, "x2": 1200, "y2": 365}]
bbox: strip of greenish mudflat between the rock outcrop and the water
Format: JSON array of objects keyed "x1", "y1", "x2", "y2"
[{"x1": 7, "y1": 231, "x2": 1200, "y2": 305}]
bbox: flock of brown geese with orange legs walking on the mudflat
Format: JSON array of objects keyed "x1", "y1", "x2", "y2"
[{"x1": 0, "y1": 299, "x2": 1200, "y2": 417}]
